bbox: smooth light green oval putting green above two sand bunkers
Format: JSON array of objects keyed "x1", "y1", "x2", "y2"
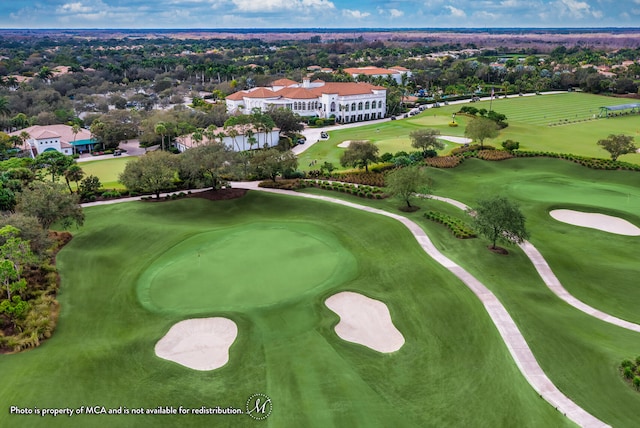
[{"x1": 138, "y1": 223, "x2": 356, "y2": 313}]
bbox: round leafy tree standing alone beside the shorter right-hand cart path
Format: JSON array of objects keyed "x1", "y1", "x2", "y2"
[{"x1": 472, "y1": 196, "x2": 529, "y2": 249}]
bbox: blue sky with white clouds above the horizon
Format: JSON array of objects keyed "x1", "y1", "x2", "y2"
[{"x1": 0, "y1": 0, "x2": 640, "y2": 28}]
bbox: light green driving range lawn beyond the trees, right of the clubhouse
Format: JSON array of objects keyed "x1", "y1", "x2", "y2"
[{"x1": 300, "y1": 93, "x2": 640, "y2": 170}]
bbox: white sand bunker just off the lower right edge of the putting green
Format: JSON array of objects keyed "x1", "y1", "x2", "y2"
[{"x1": 325, "y1": 291, "x2": 404, "y2": 352}]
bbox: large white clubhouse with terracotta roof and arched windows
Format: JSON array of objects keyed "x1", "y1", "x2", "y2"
[{"x1": 226, "y1": 79, "x2": 387, "y2": 123}]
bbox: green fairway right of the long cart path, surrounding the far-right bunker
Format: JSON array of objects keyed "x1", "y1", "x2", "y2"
[{"x1": 298, "y1": 159, "x2": 640, "y2": 427}]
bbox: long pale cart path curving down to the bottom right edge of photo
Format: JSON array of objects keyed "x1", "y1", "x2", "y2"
[{"x1": 233, "y1": 182, "x2": 609, "y2": 427}]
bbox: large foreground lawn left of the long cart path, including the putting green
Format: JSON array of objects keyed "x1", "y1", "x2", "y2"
[{"x1": 0, "y1": 192, "x2": 568, "y2": 427}]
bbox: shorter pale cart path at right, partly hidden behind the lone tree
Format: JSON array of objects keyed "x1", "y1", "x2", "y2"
[{"x1": 430, "y1": 196, "x2": 640, "y2": 333}]
